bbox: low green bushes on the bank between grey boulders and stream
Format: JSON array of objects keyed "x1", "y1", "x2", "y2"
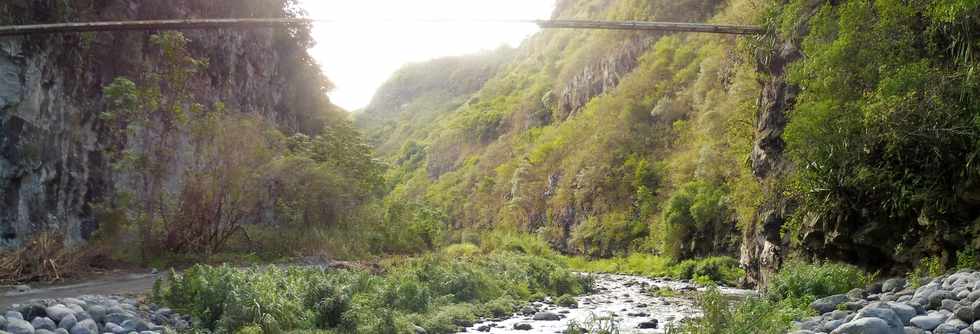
[{"x1": 161, "y1": 251, "x2": 591, "y2": 333}]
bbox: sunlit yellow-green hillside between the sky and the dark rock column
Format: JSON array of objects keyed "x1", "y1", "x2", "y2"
[{"x1": 362, "y1": 1, "x2": 760, "y2": 258}]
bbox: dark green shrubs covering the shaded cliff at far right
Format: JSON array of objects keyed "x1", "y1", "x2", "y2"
[{"x1": 775, "y1": 0, "x2": 980, "y2": 267}]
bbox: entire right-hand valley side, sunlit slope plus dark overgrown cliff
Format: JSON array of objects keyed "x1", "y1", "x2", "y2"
[{"x1": 360, "y1": 0, "x2": 980, "y2": 284}]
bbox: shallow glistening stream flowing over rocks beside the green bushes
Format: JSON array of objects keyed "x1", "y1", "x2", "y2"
[{"x1": 466, "y1": 274, "x2": 755, "y2": 334}]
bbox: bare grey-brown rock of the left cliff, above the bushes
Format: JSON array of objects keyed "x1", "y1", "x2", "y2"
[{"x1": 0, "y1": 0, "x2": 332, "y2": 247}]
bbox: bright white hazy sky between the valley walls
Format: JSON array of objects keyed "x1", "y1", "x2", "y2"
[{"x1": 301, "y1": 0, "x2": 555, "y2": 111}]
